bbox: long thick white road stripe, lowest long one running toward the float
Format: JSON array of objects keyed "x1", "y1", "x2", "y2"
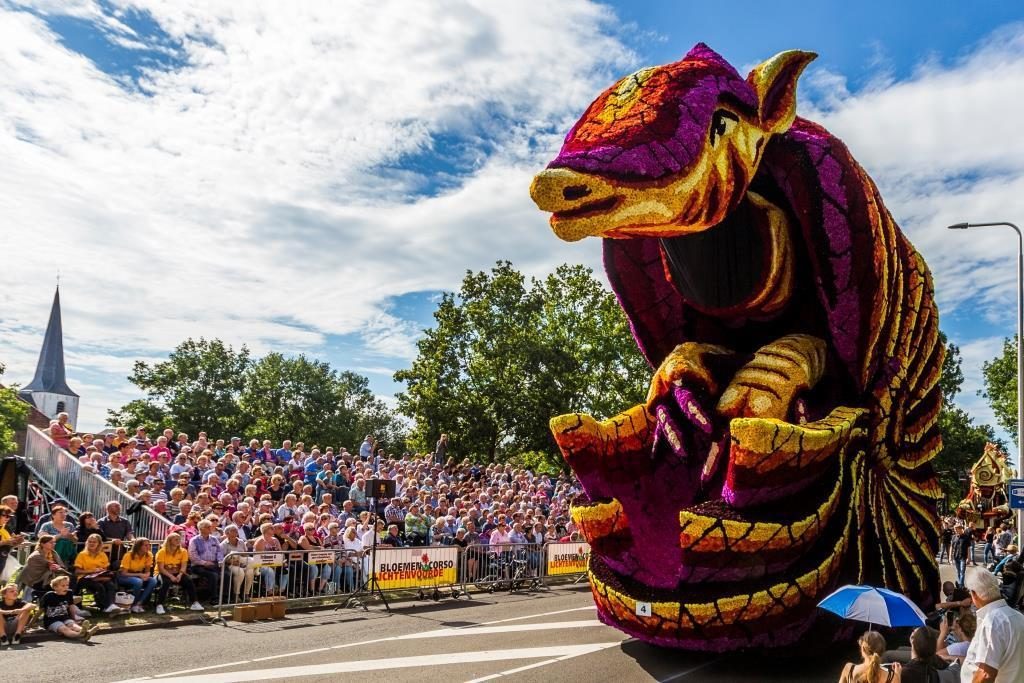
[{"x1": 117, "y1": 641, "x2": 620, "y2": 683}]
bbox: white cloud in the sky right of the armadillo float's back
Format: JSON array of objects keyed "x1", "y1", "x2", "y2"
[{"x1": 802, "y1": 25, "x2": 1024, "y2": 451}]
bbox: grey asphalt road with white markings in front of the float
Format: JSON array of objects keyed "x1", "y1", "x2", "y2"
[{"x1": 9, "y1": 587, "x2": 852, "y2": 683}]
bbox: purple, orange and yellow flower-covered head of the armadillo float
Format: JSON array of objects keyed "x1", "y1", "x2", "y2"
[{"x1": 530, "y1": 43, "x2": 816, "y2": 242}]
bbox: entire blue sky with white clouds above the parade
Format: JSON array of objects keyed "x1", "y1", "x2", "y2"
[{"x1": 0, "y1": 0, "x2": 1024, "y2": 458}]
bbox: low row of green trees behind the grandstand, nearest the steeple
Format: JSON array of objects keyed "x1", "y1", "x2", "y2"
[{"x1": 108, "y1": 339, "x2": 406, "y2": 450}]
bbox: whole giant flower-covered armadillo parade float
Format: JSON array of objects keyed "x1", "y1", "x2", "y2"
[{"x1": 530, "y1": 44, "x2": 943, "y2": 651}]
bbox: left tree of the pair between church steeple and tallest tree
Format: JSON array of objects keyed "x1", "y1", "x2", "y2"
[{"x1": 106, "y1": 337, "x2": 252, "y2": 435}]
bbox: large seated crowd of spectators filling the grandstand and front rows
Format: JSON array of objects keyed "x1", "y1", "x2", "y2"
[{"x1": 0, "y1": 425, "x2": 580, "y2": 637}]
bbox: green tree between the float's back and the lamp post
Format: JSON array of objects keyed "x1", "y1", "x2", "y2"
[{"x1": 932, "y1": 332, "x2": 999, "y2": 505}]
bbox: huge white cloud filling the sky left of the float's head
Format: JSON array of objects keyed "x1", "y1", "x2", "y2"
[{"x1": 0, "y1": 0, "x2": 633, "y2": 426}]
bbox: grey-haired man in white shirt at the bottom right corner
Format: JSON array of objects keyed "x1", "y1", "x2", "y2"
[{"x1": 961, "y1": 568, "x2": 1024, "y2": 683}]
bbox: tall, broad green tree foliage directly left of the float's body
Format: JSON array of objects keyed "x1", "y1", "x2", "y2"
[{"x1": 395, "y1": 261, "x2": 650, "y2": 465}]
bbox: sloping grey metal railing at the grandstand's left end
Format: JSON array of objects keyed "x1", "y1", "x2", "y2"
[{"x1": 25, "y1": 425, "x2": 171, "y2": 540}]
